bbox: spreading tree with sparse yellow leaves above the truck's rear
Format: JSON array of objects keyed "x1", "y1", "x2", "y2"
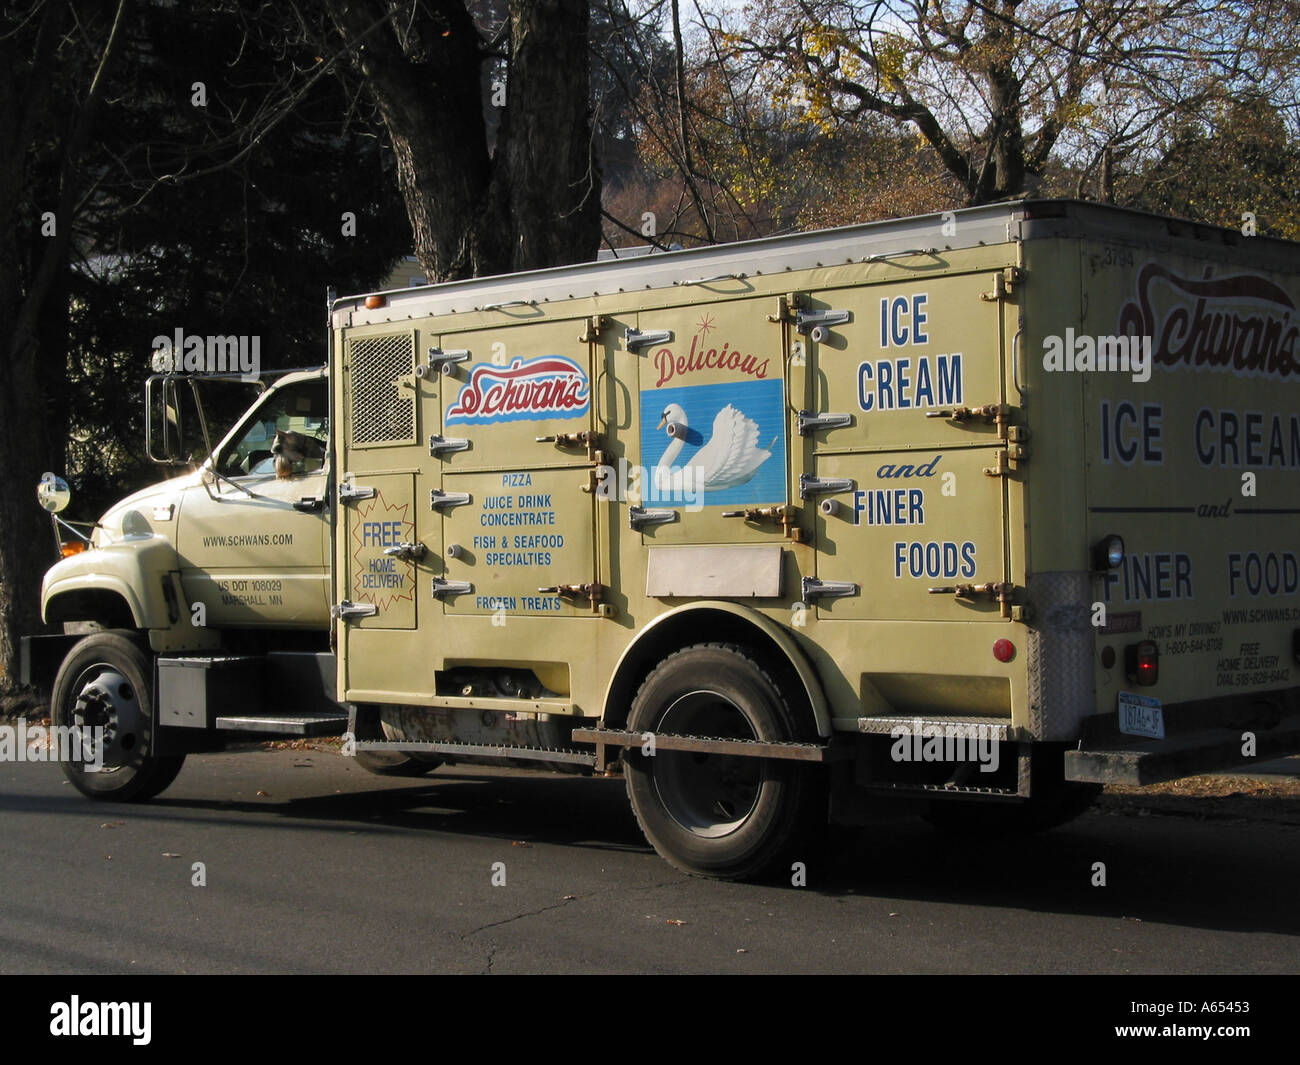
[{"x1": 714, "y1": 0, "x2": 1300, "y2": 203}]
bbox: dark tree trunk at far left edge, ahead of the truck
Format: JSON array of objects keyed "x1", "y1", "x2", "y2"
[{"x1": 0, "y1": 0, "x2": 127, "y2": 690}]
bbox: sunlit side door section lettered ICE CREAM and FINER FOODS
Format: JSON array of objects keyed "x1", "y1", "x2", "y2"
[{"x1": 805, "y1": 270, "x2": 1021, "y2": 620}]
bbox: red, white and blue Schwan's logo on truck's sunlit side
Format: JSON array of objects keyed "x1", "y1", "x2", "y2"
[{"x1": 447, "y1": 355, "x2": 590, "y2": 424}]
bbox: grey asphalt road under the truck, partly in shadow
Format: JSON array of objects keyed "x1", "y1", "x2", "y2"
[{"x1": 0, "y1": 750, "x2": 1300, "y2": 974}]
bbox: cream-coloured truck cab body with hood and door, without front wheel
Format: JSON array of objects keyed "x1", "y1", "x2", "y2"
[{"x1": 42, "y1": 369, "x2": 329, "y2": 650}]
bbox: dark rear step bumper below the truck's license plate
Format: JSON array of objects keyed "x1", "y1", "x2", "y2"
[{"x1": 1065, "y1": 715, "x2": 1300, "y2": 785}]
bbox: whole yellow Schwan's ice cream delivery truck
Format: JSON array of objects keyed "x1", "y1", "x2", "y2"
[{"x1": 30, "y1": 200, "x2": 1300, "y2": 878}]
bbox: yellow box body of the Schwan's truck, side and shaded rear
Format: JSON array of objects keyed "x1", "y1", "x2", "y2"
[{"x1": 333, "y1": 202, "x2": 1300, "y2": 779}]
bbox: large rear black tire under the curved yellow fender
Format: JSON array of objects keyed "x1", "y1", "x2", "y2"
[{"x1": 625, "y1": 644, "x2": 826, "y2": 880}]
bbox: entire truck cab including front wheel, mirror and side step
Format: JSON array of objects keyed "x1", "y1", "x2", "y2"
[{"x1": 23, "y1": 367, "x2": 346, "y2": 800}]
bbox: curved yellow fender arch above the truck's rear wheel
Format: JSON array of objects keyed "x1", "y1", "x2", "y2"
[{"x1": 605, "y1": 607, "x2": 818, "y2": 736}]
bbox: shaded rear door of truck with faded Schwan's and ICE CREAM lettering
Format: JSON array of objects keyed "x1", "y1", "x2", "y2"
[{"x1": 1073, "y1": 241, "x2": 1300, "y2": 726}]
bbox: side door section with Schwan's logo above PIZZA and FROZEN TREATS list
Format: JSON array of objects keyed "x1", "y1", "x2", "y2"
[{"x1": 431, "y1": 312, "x2": 607, "y2": 621}]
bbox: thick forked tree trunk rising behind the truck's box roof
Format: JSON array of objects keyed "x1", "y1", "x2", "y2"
[{"x1": 328, "y1": 0, "x2": 601, "y2": 281}]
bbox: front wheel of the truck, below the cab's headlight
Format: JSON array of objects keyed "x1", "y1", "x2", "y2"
[{"x1": 49, "y1": 631, "x2": 185, "y2": 802}]
